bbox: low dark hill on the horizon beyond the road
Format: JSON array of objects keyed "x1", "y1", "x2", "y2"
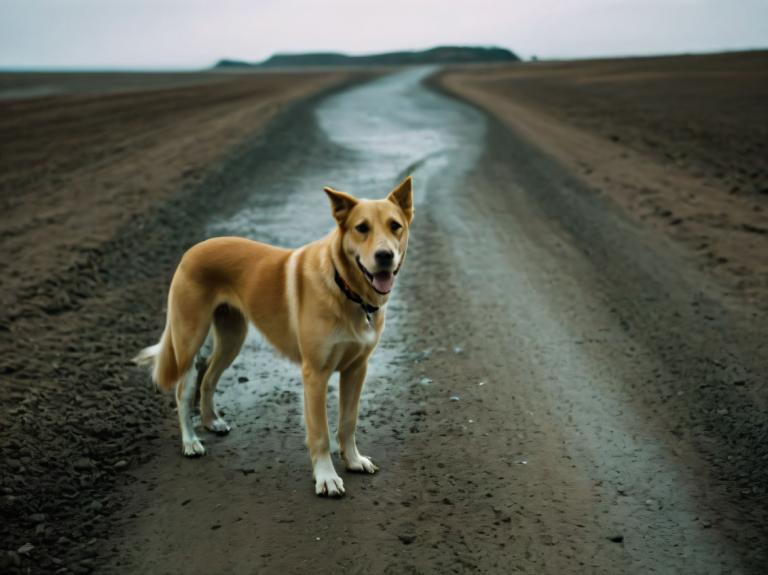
[{"x1": 214, "y1": 46, "x2": 520, "y2": 68}]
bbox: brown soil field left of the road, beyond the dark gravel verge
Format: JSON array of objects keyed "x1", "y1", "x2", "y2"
[{"x1": 0, "y1": 70, "x2": 343, "y2": 342}]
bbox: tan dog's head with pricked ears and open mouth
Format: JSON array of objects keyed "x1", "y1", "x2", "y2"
[{"x1": 325, "y1": 176, "x2": 413, "y2": 296}]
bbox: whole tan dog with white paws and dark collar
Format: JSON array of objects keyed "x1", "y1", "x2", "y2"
[{"x1": 135, "y1": 177, "x2": 413, "y2": 495}]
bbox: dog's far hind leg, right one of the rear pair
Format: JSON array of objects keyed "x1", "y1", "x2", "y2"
[{"x1": 200, "y1": 305, "x2": 248, "y2": 435}]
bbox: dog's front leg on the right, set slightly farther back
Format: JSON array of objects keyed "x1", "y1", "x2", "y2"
[{"x1": 336, "y1": 357, "x2": 379, "y2": 473}]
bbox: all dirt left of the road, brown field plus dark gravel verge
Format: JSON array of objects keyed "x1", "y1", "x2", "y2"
[{"x1": 0, "y1": 73, "x2": 372, "y2": 573}]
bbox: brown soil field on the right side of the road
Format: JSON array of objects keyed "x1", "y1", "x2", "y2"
[{"x1": 440, "y1": 51, "x2": 768, "y2": 306}]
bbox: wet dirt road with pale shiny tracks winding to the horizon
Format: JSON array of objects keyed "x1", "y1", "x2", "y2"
[{"x1": 111, "y1": 69, "x2": 768, "y2": 573}]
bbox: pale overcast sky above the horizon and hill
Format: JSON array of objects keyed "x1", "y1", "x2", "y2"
[{"x1": 0, "y1": 0, "x2": 768, "y2": 69}]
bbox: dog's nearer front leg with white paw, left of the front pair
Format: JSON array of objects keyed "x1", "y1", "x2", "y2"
[{"x1": 301, "y1": 362, "x2": 344, "y2": 496}]
